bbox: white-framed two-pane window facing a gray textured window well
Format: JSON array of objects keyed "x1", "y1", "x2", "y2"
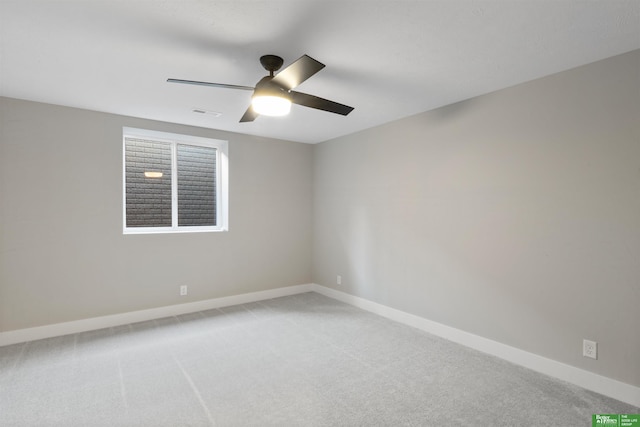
[{"x1": 123, "y1": 128, "x2": 228, "y2": 234}]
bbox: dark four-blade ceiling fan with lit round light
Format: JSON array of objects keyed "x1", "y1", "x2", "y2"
[{"x1": 167, "y1": 55, "x2": 353, "y2": 123}]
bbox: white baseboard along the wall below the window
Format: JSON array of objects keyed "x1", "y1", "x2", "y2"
[{"x1": 0, "y1": 284, "x2": 311, "y2": 347}]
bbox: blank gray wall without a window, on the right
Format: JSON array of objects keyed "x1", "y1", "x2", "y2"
[{"x1": 313, "y1": 51, "x2": 640, "y2": 386}]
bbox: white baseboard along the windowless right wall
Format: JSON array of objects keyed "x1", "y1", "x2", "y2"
[{"x1": 311, "y1": 284, "x2": 640, "y2": 407}]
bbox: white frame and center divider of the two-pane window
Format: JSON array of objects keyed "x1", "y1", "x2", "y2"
[{"x1": 122, "y1": 127, "x2": 229, "y2": 234}]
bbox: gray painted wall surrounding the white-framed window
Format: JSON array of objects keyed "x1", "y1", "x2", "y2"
[{"x1": 0, "y1": 98, "x2": 313, "y2": 331}]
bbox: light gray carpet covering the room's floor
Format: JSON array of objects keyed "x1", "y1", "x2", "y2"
[{"x1": 0, "y1": 293, "x2": 639, "y2": 427}]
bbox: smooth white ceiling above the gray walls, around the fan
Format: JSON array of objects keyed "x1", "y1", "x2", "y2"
[{"x1": 0, "y1": 0, "x2": 640, "y2": 143}]
